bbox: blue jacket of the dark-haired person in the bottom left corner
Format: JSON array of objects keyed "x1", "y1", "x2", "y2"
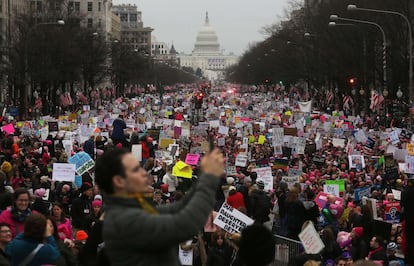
[{"x1": 6, "y1": 233, "x2": 60, "y2": 266}]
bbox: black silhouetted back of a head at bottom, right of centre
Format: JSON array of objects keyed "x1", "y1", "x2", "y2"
[{"x1": 239, "y1": 224, "x2": 276, "y2": 266}]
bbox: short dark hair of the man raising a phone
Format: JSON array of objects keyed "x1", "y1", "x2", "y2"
[{"x1": 95, "y1": 149, "x2": 129, "y2": 194}]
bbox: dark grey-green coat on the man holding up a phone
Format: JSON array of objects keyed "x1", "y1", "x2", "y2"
[{"x1": 103, "y1": 174, "x2": 219, "y2": 266}]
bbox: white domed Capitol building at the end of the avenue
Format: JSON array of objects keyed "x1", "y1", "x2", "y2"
[{"x1": 177, "y1": 13, "x2": 239, "y2": 80}]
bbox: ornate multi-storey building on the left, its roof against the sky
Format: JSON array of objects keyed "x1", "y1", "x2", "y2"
[{"x1": 112, "y1": 4, "x2": 153, "y2": 55}]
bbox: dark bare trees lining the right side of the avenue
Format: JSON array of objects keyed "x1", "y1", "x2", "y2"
[{"x1": 227, "y1": 0, "x2": 412, "y2": 97}]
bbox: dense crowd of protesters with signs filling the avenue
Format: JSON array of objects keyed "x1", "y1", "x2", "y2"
[{"x1": 0, "y1": 83, "x2": 414, "y2": 266}]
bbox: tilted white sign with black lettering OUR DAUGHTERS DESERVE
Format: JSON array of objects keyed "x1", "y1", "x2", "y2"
[{"x1": 213, "y1": 203, "x2": 254, "y2": 234}]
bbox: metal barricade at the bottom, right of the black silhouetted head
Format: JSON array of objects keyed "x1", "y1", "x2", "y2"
[{"x1": 272, "y1": 235, "x2": 302, "y2": 266}]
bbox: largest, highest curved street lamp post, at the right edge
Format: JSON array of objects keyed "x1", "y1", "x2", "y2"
[{"x1": 347, "y1": 5, "x2": 414, "y2": 103}]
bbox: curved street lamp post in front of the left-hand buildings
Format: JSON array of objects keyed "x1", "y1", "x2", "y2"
[{"x1": 22, "y1": 20, "x2": 65, "y2": 117}]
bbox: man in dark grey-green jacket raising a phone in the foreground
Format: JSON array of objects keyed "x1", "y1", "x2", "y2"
[{"x1": 95, "y1": 149, "x2": 224, "y2": 266}]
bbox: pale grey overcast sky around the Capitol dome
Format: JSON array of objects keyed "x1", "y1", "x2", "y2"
[{"x1": 113, "y1": 0, "x2": 288, "y2": 55}]
